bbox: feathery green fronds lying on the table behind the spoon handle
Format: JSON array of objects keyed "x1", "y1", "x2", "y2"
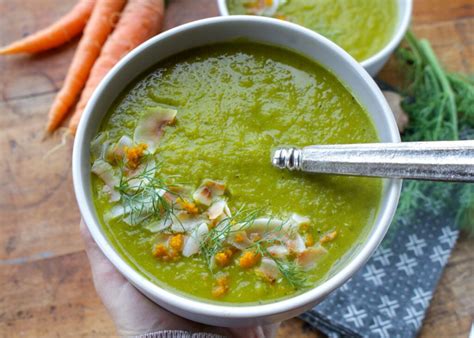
[{"x1": 396, "y1": 32, "x2": 474, "y2": 233}]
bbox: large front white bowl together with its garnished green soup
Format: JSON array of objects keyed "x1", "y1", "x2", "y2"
[{"x1": 73, "y1": 17, "x2": 400, "y2": 326}]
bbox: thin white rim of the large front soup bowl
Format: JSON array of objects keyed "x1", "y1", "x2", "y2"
[{"x1": 72, "y1": 16, "x2": 401, "y2": 319}]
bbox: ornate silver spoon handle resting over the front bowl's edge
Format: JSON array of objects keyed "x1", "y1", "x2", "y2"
[{"x1": 272, "y1": 140, "x2": 474, "y2": 182}]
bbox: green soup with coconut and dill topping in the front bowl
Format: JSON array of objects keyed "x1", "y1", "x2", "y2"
[{"x1": 91, "y1": 43, "x2": 382, "y2": 304}]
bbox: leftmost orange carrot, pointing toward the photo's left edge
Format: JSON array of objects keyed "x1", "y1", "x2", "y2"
[{"x1": 0, "y1": 0, "x2": 96, "y2": 55}]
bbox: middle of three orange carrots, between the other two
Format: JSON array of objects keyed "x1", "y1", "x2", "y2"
[{"x1": 46, "y1": 0, "x2": 125, "y2": 132}]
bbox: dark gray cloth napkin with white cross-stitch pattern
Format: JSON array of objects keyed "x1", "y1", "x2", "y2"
[{"x1": 301, "y1": 184, "x2": 459, "y2": 338}]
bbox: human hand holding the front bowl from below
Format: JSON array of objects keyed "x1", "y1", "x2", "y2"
[{"x1": 81, "y1": 221, "x2": 279, "y2": 338}]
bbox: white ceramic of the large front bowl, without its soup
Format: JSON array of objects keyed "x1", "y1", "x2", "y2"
[{"x1": 72, "y1": 16, "x2": 401, "y2": 327}]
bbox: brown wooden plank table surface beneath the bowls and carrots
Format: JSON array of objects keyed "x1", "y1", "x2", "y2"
[{"x1": 0, "y1": 0, "x2": 474, "y2": 337}]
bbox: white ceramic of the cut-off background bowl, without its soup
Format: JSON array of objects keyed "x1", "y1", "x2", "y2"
[{"x1": 217, "y1": 0, "x2": 413, "y2": 76}]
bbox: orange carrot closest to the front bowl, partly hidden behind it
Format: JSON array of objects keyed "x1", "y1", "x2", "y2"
[{"x1": 69, "y1": 0, "x2": 164, "y2": 134}]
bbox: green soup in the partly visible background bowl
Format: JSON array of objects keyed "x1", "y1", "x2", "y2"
[{"x1": 227, "y1": 0, "x2": 398, "y2": 61}]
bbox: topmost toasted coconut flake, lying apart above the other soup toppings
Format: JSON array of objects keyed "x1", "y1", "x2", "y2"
[{"x1": 133, "y1": 106, "x2": 178, "y2": 154}]
